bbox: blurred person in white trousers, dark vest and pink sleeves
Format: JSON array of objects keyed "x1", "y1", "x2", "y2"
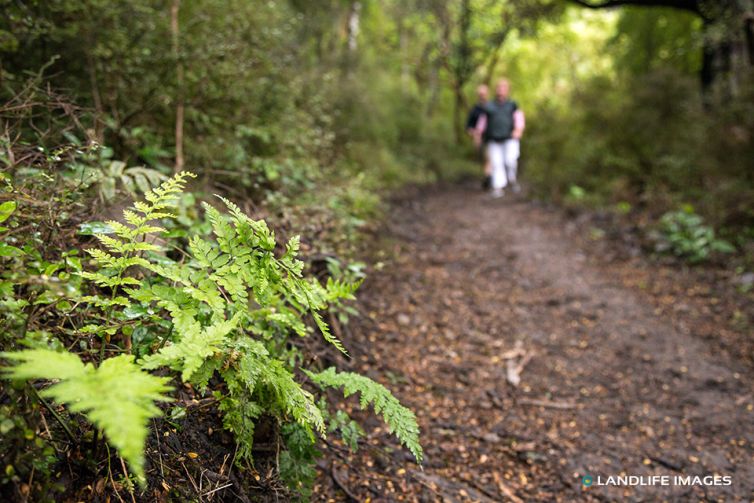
[{"x1": 477, "y1": 79, "x2": 525, "y2": 197}]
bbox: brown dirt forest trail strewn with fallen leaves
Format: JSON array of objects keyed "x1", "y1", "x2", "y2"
[{"x1": 320, "y1": 189, "x2": 754, "y2": 501}]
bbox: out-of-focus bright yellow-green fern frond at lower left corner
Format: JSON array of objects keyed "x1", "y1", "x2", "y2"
[{"x1": 2, "y1": 349, "x2": 170, "y2": 484}]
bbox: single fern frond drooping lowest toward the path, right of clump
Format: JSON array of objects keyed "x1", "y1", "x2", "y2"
[{"x1": 304, "y1": 367, "x2": 424, "y2": 463}]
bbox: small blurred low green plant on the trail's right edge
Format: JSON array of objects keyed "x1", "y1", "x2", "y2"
[{"x1": 657, "y1": 208, "x2": 736, "y2": 263}]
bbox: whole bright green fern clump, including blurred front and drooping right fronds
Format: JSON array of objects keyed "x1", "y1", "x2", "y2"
[{"x1": 4, "y1": 173, "x2": 421, "y2": 494}]
